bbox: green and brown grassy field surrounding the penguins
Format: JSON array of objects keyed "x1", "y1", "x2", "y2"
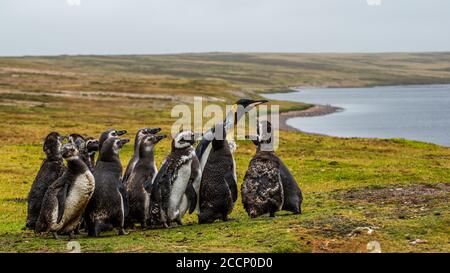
[{"x1": 0, "y1": 53, "x2": 450, "y2": 252}]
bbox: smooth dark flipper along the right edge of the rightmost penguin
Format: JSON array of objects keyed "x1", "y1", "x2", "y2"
[{"x1": 278, "y1": 159, "x2": 303, "y2": 213}]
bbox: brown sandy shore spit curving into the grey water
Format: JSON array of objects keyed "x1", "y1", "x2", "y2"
[{"x1": 280, "y1": 104, "x2": 344, "y2": 131}]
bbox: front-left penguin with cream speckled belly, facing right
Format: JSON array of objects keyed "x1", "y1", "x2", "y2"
[{"x1": 35, "y1": 142, "x2": 95, "y2": 239}]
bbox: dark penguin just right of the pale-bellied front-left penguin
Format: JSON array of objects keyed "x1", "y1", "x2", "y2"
[{"x1": 85, "y1": 137, "x2": 129, "y2": 237}]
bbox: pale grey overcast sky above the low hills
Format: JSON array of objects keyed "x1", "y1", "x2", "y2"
[{"x1": 0, "y1": 0, "x2": 450, "y2": 56}]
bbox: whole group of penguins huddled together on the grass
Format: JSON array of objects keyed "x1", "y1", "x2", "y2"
[{"x1": 25, "y1": 99, "x2": 302, "y2": 239}]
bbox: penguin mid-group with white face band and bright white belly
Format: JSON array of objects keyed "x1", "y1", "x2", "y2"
[{"x1": 149, "y1": 131, "x2": 201, "y2": 228}]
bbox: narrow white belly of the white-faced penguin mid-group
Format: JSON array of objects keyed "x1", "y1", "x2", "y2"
[{"x1": 168, "y1": 162, "x2": 191, "y2": 220}]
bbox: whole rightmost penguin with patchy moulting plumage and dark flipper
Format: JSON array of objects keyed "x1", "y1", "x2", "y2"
[{"x1": 241, "y1": 121, "x2": 303, "y2": 217}]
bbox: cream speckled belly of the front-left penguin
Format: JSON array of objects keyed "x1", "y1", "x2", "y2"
[{"x1": 57, "y1": 171, "x2": 95, "y2": 229}]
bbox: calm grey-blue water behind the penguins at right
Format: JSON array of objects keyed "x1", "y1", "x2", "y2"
[{"x1": 265, "y1": 85, "x2": 450, "y2": 146}]
